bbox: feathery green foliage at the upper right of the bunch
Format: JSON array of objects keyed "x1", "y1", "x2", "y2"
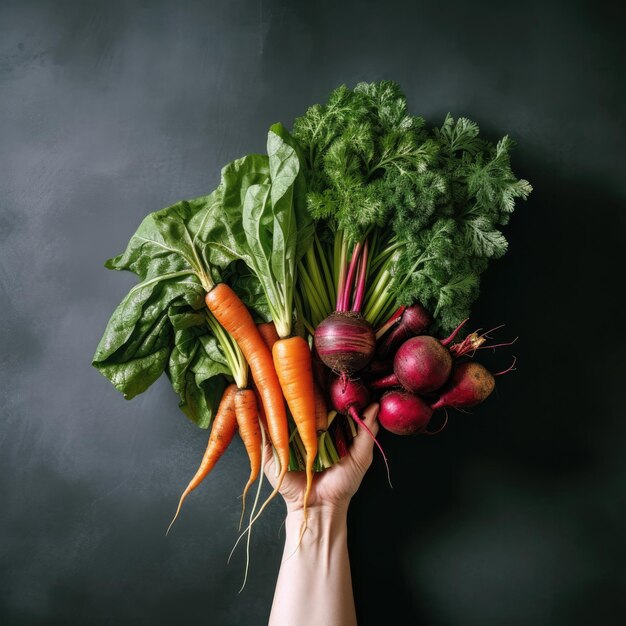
[{"x1": 293, "y1": 81, "x2": 532, "y2": 331}]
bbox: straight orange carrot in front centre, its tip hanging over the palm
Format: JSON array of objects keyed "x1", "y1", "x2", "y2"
[{"x1": 272, "y1": 336, "x2": 317, "y2": 531}]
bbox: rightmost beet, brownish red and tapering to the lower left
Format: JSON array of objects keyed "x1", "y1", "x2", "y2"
[{"x1": 431, "y1": 361, "x2": 496, "y2": 410}]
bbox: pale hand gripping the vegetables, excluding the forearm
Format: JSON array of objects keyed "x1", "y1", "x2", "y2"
[{"x1": 264, "y1": 403, "x2": 379, "y2": 513}]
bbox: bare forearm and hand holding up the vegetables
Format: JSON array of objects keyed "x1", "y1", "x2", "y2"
[{"x1": 265, "y1": 404, "x2": 378, "y2": 626}]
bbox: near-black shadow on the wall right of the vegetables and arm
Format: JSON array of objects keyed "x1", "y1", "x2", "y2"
[{"x1": 349, "y1": 157, "x2": 626, "y2": 626}]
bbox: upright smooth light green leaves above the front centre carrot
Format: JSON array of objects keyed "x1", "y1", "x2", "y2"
[{"x1": 199, "y1": 125, "x2": 313, "y2": 336}]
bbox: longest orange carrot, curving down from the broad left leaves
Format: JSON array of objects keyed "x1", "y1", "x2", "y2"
[{"x1": 205, "y1": 283, "x2": 289, "y2": 504}]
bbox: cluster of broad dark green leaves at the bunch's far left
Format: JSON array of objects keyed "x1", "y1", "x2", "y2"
[{"x1": 93, "y1": 189, "x2": 228, "y2": 427}]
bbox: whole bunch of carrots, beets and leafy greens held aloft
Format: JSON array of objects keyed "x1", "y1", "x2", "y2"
[{"x1": 93, "y1": 81, "x2": 531, "y2": 530}]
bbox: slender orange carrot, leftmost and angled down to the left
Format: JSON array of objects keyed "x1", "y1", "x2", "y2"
[{"x1": 165, "y1": 383, "x2": 237, "y2": 535}]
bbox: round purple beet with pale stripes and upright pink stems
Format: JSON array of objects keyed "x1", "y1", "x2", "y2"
[{"x1": 313, "y1": 311, "x2": 376, "y2": 374}]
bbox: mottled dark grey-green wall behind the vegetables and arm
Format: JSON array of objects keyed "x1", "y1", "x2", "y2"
[{"x1": 0, "y1": 0, "x2": 626, "y2": 626}]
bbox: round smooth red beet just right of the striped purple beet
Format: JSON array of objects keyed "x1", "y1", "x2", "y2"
[{"x1": 370, "y1": 335, "x2": 452, "y2": 393}]
